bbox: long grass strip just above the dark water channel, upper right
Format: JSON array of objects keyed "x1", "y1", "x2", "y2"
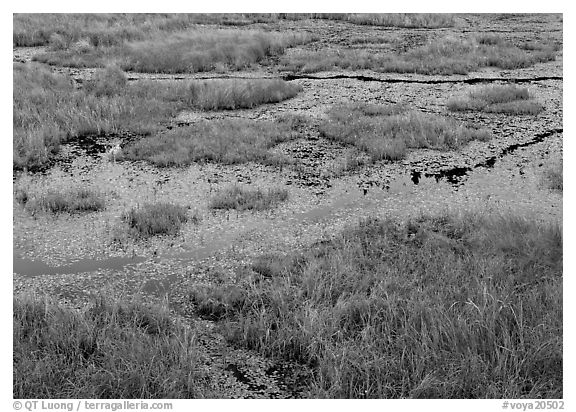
[{"x1": 280, "y1": 37, "x2": 558, "y2": 75}]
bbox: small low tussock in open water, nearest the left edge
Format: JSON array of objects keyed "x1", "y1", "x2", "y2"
[{"x1": 15, "y1": 187, "x2": 106, "y2": 214}]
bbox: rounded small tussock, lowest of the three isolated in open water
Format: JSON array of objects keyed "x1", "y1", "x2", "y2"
[{"x1": 122, "y1": 202, "x2": 188, "y2": 238}]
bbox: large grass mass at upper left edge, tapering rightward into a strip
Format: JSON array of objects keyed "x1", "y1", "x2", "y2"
[{"x1": 13, "y1": 64, "x2": 301, "y2": 169}]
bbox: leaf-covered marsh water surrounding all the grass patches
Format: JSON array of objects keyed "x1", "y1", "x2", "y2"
[{"x1": 13, "y1": 15, "x2": 563, "y2": 397}]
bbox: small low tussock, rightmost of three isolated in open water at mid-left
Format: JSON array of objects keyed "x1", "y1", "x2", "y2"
[{"x1": 209, "y1": 185, "x2": 288, "y2": 210}]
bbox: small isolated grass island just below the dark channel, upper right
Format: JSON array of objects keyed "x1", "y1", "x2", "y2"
[{"x1": 447, "y1": 85, "x2": 544, "y2": 115}]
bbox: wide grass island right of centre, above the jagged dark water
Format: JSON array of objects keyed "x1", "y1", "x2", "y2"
[{"x1": 320, "y1": 103, "x2": 491, "y2": 161}]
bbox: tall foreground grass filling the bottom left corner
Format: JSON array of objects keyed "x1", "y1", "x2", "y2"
[{"x1": 13, "y1": 296, "x2": 218, "y2": 399}]
